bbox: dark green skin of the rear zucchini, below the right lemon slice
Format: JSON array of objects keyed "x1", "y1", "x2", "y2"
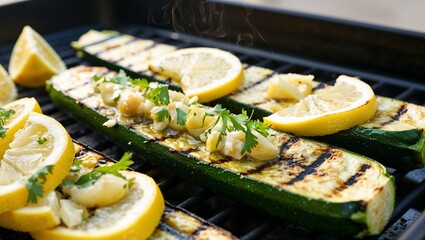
[{"x1": 216, "y1": 97, "x2": 425, "y2": 170}]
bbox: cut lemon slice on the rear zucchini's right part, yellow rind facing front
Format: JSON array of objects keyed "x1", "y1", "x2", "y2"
[{"x1": 264, "y1": 76, "x2": 377, "y2": 136}]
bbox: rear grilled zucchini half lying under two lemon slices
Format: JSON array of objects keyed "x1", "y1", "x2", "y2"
[{"x1": 73, "y1": 30, "x2": 425, "y2": 169}]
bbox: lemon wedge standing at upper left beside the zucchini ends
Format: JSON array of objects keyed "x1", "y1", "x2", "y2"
[{"x1": 9, "y1": 26, "x2": 66, "y2": 87}]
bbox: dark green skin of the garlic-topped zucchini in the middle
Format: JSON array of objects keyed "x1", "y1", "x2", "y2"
[{"x1": 47, "y1": 66, "x2": 395, "y2": 237}]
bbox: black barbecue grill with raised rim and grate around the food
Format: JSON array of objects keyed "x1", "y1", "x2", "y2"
[{"x1": 0, "y1": 0, "x2": 425, "y2": 239}]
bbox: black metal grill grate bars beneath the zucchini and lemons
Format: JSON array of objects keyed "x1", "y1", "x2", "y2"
[{"x1": 0, "y1": 25, "x2": 425, "y2": 240}]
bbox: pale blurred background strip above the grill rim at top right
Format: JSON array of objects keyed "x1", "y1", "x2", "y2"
[{"x1": 222, "y1": 0, "x2": 425, "y2": 33}]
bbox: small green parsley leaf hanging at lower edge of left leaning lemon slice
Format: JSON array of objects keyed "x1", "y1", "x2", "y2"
[{"x1": 26, "y1": 165, "x2": 54, "y2": 203}]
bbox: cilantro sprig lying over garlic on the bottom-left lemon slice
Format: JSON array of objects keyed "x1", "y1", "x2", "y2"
[{"x1": 62, "y1": 152, "x2": 134, "y2": 188}]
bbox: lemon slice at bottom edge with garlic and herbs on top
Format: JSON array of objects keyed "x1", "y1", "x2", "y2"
[{"x1": 31, "y1": 171, "x2": 165, "y2": 240}]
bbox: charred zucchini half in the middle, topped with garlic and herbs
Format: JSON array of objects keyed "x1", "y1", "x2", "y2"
[{"x1": 47, "y1": 66, "x2": 395, "y2": 237}]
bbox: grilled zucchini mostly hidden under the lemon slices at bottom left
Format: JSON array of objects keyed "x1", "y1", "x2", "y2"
[{"x1": 74, "y1": 141, "x2": 236, "y2": 240}]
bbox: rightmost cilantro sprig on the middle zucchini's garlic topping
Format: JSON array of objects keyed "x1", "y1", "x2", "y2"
[{"x1": 203, "y1": 104, "x2": 270, "y2": 154}]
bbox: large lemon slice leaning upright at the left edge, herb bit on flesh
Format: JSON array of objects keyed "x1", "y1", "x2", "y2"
[{"x1": 0, "y1": 112, "x2": 74, "y2": 214}]
